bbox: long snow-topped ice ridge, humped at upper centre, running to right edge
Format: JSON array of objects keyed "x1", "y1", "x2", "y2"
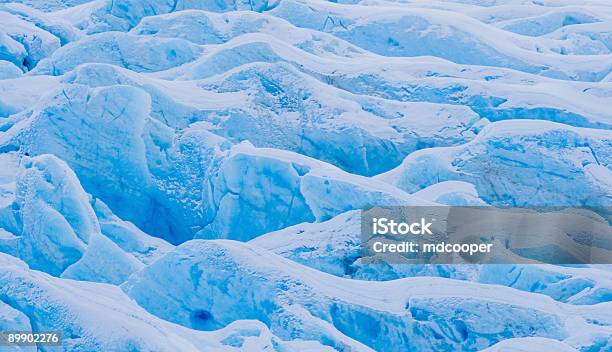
[{"x1": 157, "y1": 33, "x2": 612, "y2": 129}]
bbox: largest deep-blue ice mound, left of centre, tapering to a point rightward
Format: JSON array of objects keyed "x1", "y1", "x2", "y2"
[{"x1": 4, "y1": 84, "x2": 426, "y2": 243}]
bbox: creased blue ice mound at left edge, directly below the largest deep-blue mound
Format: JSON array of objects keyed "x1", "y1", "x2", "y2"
[{"x1": 0, "y1": 154, "x2": 143, "y2": 284}]
